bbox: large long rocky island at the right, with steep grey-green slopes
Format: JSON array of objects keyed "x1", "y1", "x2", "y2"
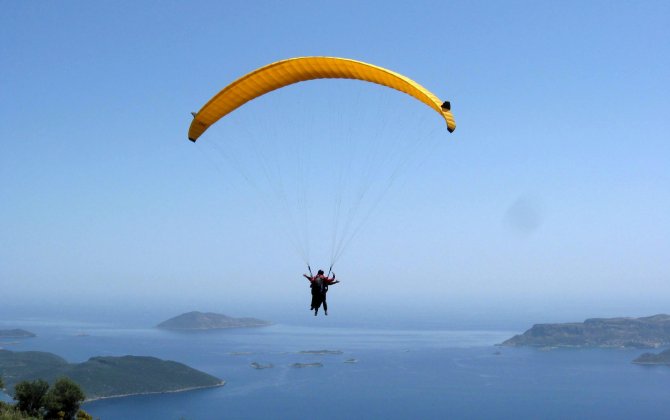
[{"x1": 500, "y1": 314, "x2": 670, "y2": 348}]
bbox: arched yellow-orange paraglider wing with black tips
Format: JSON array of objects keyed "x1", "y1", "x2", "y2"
[{"x1": 188, "y1": 57, "x2": 456, "y2": 142}]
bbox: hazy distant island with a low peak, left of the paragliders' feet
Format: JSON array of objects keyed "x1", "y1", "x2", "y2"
[{"x1": 156, "y1": 311, "x2": 272, "y2": 331}]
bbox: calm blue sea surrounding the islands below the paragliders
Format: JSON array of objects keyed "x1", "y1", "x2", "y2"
[{"x1": 0, "y1": 322, "x2": 670, "y2": 419}]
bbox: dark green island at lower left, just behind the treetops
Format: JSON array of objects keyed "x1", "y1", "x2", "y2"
[{"x1": 0, "y1": 350, "x2": 225, "y2": 401}]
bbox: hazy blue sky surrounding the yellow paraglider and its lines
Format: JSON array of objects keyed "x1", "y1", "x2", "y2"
[{"x1": 0, "y1": 0, "x2": 670, "y2": 322}]
